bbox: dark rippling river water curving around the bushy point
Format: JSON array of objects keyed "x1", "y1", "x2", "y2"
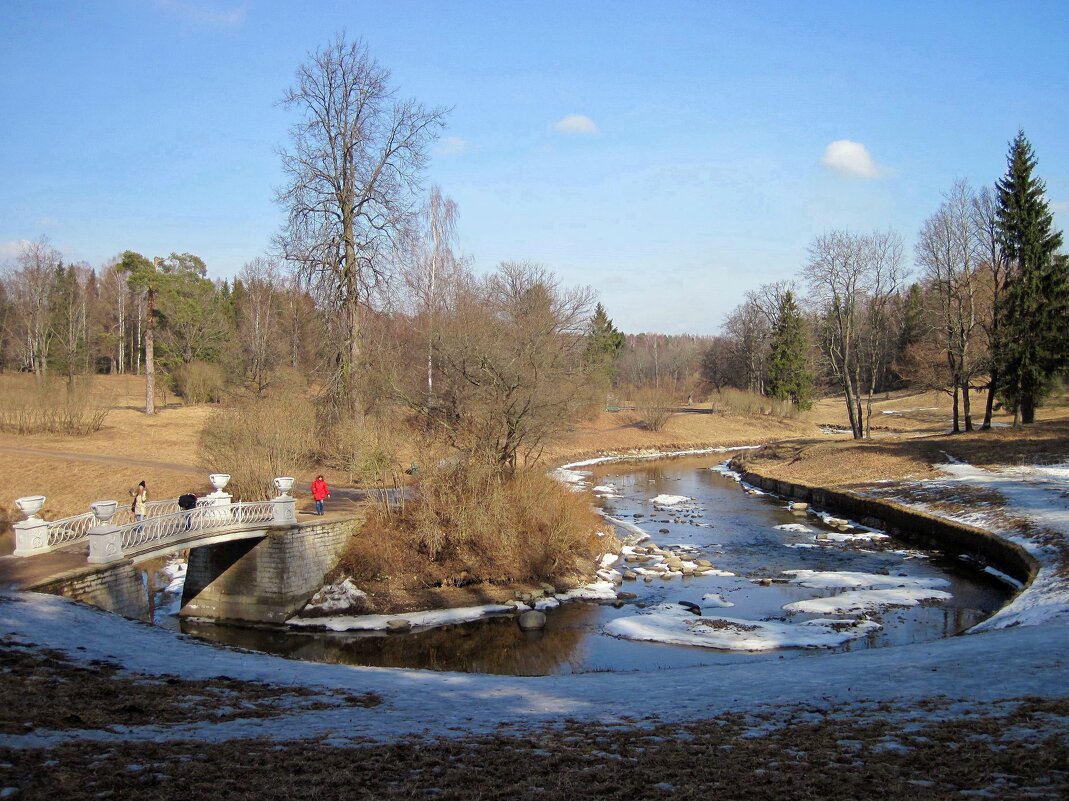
[{"x1": 157, "y1": 455, "x2": 1011, "y2": 675}]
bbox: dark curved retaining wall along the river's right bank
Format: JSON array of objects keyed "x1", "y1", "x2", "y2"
[{"x1": 731, "y1": 461, "x2": 1039, "y2": 584}]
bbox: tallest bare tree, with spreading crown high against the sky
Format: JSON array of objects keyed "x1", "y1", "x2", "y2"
[{"x1": 278, "y1": 35, "x2": 446, "y2": 415}]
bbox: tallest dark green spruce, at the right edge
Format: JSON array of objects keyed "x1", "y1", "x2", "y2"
[{"x1": 995, "y1": 132, "x2": 1069, "y2": 423}]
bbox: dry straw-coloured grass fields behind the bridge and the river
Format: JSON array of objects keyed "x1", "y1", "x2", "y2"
[{"x1": 0, "y1": 375, "x2": 1069, "y2": 553}]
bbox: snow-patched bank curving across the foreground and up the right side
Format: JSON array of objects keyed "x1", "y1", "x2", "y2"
[{"x1": 6, "y1": 399, "x2": 1069, "y2": 801}]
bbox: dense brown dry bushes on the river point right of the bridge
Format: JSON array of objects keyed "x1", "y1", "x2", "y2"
[{"x1": 345, "y1": 462, "x2": 611, "y2": 586}]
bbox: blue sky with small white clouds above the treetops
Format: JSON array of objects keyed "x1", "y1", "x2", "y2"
[{"x1": 0, "y1": 0, "x2": 1069, "y2": 334}]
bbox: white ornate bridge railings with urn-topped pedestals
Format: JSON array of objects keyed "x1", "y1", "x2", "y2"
[{"x1": 13, "y1": 474, "x2": 297, "y2": 564}]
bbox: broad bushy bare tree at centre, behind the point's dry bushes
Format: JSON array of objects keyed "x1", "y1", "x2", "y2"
[{"x1": 406, "y1": 263, "x2": 597, "y2": 471}]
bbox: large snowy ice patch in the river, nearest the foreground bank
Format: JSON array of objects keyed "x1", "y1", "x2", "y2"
[{"x1": 605, "y1": 605, "x2": 880, "y2": 651}]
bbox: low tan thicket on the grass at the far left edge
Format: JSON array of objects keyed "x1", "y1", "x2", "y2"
[{"x1": 0, "y1": 375, "x2": 110, "y2": 436}]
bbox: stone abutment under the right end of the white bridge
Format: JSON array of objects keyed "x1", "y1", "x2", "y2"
[{"x1": 179, "y1": 520, "x2": 356, "y2": 623}]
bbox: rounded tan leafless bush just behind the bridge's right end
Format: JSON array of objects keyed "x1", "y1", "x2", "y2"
[{"x1": 201, "y1": 395, "x2": 317, "y2": 500}]
